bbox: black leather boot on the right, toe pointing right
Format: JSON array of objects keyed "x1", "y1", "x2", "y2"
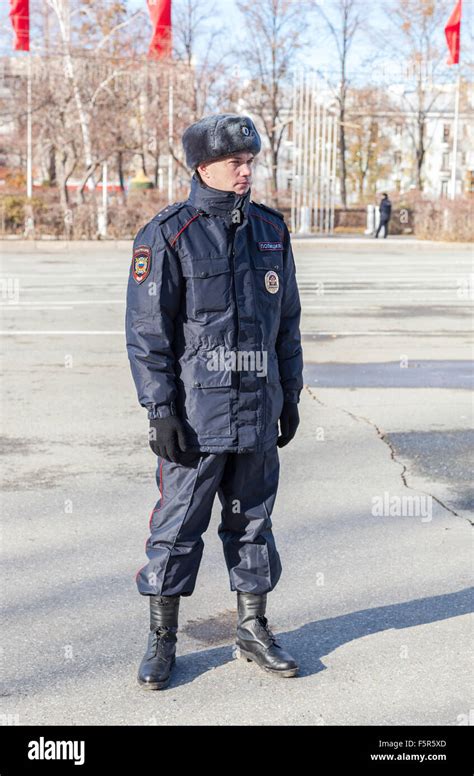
[{"x1": 232, "y1": 592, "x2": 299, "y2": 677}]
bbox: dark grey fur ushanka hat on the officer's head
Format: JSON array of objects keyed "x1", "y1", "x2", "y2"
[{"x1": 182, "y1": 113, "x2": 262, "y2": 170}]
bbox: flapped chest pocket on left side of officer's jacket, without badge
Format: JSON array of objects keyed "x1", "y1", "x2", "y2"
[{"x1": 181, "y1": 256, "x2": 231, "y2": 318}]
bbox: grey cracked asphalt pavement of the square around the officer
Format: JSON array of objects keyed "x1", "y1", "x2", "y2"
[{"x1": 0, "y1": 238, "x2": 474, "y2": 725}]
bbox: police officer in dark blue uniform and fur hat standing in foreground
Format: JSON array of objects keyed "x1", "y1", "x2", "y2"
[{"x1": 126, "y1": 114, "x2": 303, "y2": 689}]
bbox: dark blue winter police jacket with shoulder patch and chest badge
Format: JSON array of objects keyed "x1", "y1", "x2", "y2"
[{"x1": 126, "y1": 173, "x2": 303, "y2": 453}]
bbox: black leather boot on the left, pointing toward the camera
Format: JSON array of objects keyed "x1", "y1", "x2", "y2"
[{"x1": 138, "y1": 595, "x2": 180, "y2": 690}]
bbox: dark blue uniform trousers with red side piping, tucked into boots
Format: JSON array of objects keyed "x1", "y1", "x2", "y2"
[{"x1": 136, "y1": 445, "x2": 282, "y2": 596}]
